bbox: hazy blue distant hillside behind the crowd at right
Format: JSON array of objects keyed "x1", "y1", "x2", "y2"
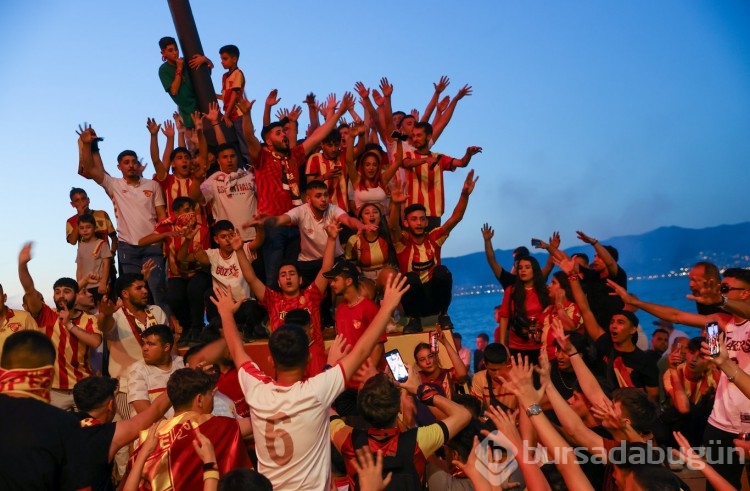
[{"x1": 443, "y1": 222, "x2": 750, "y2": 289}]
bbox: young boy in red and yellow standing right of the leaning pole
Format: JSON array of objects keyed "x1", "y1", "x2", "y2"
[{"x1": 216, "y1": 44, "x2": 250, "y2": 166}]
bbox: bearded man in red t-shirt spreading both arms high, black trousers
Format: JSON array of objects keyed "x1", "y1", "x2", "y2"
[{"x1": 240, "y1": 92, "x2": 354, "y2": 286}]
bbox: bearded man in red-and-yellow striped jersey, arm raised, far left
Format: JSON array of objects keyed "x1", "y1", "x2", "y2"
[{"x1": 18, "y1": 242, "x2": 102, "y2": 409}]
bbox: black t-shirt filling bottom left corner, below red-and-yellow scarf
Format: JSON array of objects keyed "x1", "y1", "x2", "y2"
[{"x1": 0, "y1": 394, "x2": 88, "y2": 491}]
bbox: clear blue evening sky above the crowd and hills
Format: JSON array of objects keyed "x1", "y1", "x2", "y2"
[{"x1": 0, "y1": 0, "x2": 750, "y2": 305}]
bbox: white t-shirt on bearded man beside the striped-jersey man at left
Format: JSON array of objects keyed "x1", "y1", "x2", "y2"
[{"x1": 105, "y1": 305, "x2": 167, "y2": 392}]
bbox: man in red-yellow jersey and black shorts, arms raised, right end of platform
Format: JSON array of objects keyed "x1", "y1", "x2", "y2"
[{"x1": 389, "y1": 170, "x2": 479, "y2": 333}]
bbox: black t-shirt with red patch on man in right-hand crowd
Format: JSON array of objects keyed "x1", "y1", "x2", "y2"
[{"x1": 594, "y1": 333, "x2": 659, "y2": 389}]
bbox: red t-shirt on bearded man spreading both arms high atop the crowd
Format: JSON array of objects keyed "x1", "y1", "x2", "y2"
[{"x1": 253, "y1": 145, "x2": 305, "y2": 216}]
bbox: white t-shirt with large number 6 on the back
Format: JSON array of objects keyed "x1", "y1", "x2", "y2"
[{"x1": 238, "y1": 362, "x2": 345, "y2": 491}]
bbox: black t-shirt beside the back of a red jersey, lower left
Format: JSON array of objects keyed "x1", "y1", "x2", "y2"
[{"x1": 74, "y1": 413, "x2": 117, "y2": 491}]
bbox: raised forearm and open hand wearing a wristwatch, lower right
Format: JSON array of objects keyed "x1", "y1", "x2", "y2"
[{"x1": 503, "y1": 356, "x2": 594, "y2": 491}]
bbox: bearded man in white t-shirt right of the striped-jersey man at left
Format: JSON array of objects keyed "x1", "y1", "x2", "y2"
[{"x1": 102, "y1": 274, "x2": 167, "y2": 418}]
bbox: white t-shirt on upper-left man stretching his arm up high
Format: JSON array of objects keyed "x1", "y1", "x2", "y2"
[{"x1": 102, "y1": 174, "x2": 166, "y2": 246}]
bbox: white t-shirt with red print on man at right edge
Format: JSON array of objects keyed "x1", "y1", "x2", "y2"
[{"x1": 708, "y1": 320, "x2": 750, "y2": 433}]
